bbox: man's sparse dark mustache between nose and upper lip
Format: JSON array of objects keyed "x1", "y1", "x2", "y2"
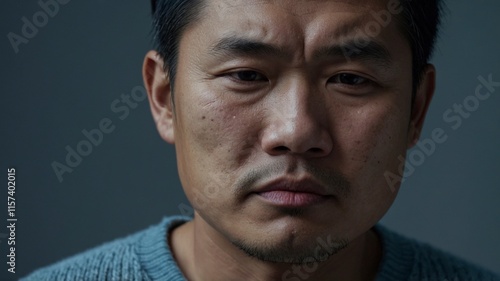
[{"x1": 235, "y1": 163, "x2": 351, "y2": 198}]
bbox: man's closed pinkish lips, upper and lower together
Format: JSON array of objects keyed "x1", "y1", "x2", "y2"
[{"x1": 254, "y1": 179, "x2": 332, "y2": 208}]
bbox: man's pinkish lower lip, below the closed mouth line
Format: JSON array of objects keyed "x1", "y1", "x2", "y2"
[{"x1": 257, "y1": 190, "x2": 328, "y2": 208}]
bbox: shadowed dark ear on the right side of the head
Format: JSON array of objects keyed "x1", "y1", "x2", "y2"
[{"x1": 408, "y1": 64, "x2": 436, "y2": 148}]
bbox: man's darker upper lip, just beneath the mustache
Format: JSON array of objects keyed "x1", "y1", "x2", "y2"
[{"x1": 255, "y1": 178, "x2": 331, "y2": 196}]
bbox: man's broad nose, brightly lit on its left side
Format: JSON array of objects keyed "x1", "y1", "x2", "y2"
[{"x1": 261, "y1": 75, "x2": 333, "y2": 157}]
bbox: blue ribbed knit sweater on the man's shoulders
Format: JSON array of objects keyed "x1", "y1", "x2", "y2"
[{"x1": 21, "y1": 217, "x2": 500, "y2": 281}]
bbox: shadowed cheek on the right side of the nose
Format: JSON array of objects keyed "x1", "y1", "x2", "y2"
[{"x1": 337, "y1": 102, "x2": 409, "y2": 187}]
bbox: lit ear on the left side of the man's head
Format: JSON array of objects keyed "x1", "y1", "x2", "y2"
[{"x1": 142, "y1": 51, "x2": 174, "y2": 144}]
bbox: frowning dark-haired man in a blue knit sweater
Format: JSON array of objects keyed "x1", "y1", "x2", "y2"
[{"x1": 21, "y1": 0, "x2": 500, "y2": 281}]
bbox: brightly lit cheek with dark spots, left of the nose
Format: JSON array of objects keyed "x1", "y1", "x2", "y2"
[{"x1": 175, "y1": 89, "x2": 256, "y2": 203}]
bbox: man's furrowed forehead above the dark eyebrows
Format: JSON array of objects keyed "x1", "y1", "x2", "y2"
[{"x1": 186, "y1": 0, "x2": 403, "y2": 58}]
